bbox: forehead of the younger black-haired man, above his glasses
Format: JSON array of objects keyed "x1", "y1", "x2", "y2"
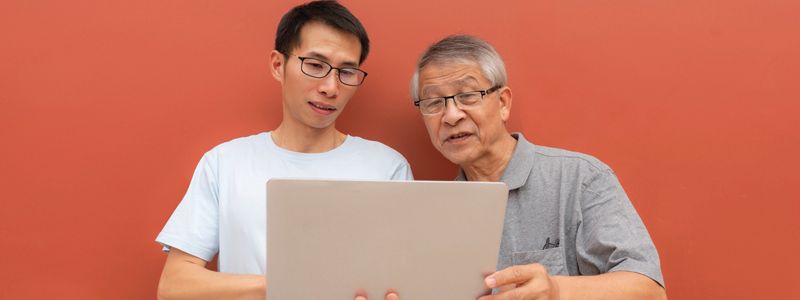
[{"x1": 294, "y1": 21, "x2": 361, "y2": 66}]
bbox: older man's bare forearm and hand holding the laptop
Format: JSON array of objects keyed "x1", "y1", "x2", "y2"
[{"x1": 479, "y1": 264, "x2": 667, "y2": 300}]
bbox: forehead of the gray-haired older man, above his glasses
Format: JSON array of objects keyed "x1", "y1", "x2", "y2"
[{"x1": 419, "y1": 63, "x2": 489, "y2": 95}]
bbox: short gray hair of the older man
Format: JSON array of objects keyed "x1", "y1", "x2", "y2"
[{"x1": 411, "y1": 35, "x2": 508, "y2": 101}]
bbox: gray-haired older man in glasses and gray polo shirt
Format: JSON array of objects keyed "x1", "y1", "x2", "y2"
[{"x1": 410, "y1": 36, "x2": 666, "y2": 299}]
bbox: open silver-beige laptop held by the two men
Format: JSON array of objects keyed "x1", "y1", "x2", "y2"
[{"x1": 266, "y1": 179, "x2": 508, "y2": 300}]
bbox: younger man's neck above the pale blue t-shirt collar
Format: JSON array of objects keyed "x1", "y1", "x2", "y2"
[{"x1": 272, "y1": 123, "x2": 345, "y2": 153}]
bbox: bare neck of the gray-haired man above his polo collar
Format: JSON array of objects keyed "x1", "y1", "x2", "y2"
[{"x1": 461, "y1": 133, "x2": 517, "y2": 182}]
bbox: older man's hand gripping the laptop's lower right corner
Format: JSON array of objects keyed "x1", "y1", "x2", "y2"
[{"x1": 478, "y1": 264, "x2": 559, "y2": 300}]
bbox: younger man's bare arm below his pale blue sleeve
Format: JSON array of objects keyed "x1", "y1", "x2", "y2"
[{"x1": 158, "y1": 248, "x2": 267, "y2": 300}]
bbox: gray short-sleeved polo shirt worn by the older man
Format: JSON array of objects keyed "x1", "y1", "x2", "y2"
[{"x1": 456, "y1": 133, "x2": 664, "y2": 286}]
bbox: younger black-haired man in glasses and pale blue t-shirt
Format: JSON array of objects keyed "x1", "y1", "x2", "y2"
[{"x1": 156, "y1": 1, "x2": 412, "y2": 299}]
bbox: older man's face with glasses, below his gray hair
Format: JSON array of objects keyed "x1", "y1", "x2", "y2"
[{"x1": 418, "y1": 64, "x2": 511, "y2": 167}]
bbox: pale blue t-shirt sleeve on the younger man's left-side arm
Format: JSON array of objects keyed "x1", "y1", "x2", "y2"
[{"x1": 156, "y1": 150, "x2": 219, "y2": 261}]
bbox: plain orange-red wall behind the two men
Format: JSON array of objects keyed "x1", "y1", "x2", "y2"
[{"x1": 0, "y1": 0, "x2": 800, "y2": 299}]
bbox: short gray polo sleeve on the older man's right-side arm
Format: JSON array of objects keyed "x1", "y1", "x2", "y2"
[{"x1": 576, "y1": 170, "x2": 664, "y2": 286}]
